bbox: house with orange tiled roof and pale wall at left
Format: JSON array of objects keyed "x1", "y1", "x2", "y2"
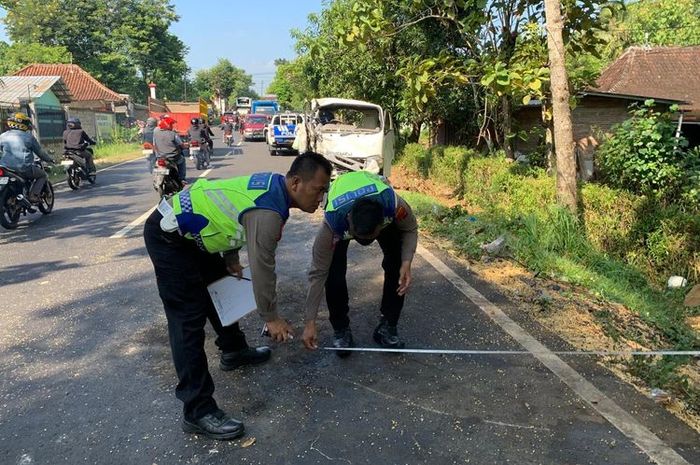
[{"x1": 14, "y1": 63, "x2": 128, "y2": 140}]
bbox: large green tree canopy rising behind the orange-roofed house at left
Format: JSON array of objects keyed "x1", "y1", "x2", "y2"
[{"x1": 0, "y1": 0, "x2": 187, "y2": 99}]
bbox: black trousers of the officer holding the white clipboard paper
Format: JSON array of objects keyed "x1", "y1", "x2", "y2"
[{"x1": 143, "y1": 210, "x2": 248, "y2": 421}]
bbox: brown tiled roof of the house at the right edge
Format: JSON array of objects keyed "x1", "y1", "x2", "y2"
[{"x1": 596, "y1": 46, "x2": 700, "y2": 117}]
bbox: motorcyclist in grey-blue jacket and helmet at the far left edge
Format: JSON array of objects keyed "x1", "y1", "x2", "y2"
[{"x1": 0, "y1": 113, "x2": 55, "y2": 203}]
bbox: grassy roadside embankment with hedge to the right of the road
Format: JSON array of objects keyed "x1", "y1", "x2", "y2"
[{"x1": 397, "y1": 144, "x2": 700, "y2": 414}]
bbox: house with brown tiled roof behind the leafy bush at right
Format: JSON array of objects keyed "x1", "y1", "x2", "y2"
[{"x1": 514, "y1": 46, "x2": 700, "y2": 178}]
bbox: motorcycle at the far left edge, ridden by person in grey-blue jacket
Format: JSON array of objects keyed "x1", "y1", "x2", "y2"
[{"x1": 0, "y1": 161, "x2": 54, "y2": 229}]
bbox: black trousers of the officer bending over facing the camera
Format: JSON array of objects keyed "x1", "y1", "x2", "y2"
[{"x1": 326, "y1": 223, "x2": 404, "y2": 331}]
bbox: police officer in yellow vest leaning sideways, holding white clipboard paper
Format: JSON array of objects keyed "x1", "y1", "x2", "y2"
[{"x1": 144, "y1": 153, "x2": 331, "y2": 440}]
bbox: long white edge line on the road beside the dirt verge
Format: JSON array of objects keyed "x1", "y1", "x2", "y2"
[{"x1": 418, "y1": 245, "x2": 690, "y2": 465}]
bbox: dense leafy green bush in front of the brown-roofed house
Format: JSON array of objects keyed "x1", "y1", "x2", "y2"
[{"x1": 596, "y1": 100, "x2": 700, "y2": 202}]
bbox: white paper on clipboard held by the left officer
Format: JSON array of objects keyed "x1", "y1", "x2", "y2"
[{"x1": 207, "y1": 268, "x2": 257, "y2": 326}]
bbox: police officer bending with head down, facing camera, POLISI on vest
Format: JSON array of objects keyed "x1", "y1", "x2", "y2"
[{"x1": 303, "y1": 171, "x2": 418, "y2": 357}]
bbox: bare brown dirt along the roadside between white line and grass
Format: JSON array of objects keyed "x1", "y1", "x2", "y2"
[{"x1": 391, "y1": 167, "x2": 700, "y2": 433}]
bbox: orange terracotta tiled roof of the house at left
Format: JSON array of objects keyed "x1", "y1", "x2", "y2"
[{"x1": 15, "y1": 64, "x2": 124, "y2": 102}]
